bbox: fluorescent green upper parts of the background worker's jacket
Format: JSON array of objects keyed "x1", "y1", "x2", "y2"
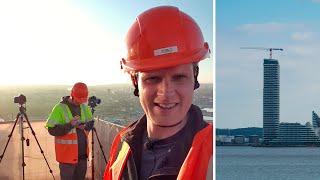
[{"x1": 45, "y1": 103, "x2": 93, "y2": 128}]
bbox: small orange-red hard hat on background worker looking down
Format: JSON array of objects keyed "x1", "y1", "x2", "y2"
[{"x1": 71, "y1": 82, "x2": 89, "y2": 103}]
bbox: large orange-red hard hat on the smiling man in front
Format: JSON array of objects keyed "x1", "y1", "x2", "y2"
[{"x1": 121, "y1": 6, "x2": 210, "y2": 72}]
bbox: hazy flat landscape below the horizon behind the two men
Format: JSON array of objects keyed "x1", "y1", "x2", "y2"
[{"x1": 0, "y1": 84, "x2": 213, "y2": 125}]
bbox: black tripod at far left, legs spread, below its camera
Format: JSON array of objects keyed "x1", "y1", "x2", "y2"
[{"x1": 0, "y1": 103, "x2": 55, "y2": 180}]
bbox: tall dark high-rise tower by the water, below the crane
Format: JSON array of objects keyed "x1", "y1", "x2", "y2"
[{"x1": 263, "y1": 59, "x2": 280, "y2": 142}]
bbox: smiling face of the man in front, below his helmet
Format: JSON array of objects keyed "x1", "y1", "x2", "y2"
[{"x1": 138, "y1": 64, "x2": 194, "y2": 126}]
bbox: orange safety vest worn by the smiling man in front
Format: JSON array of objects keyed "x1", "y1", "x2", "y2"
[{"x1": 104, "y1": 124, "x2": 213, "y2": 180}]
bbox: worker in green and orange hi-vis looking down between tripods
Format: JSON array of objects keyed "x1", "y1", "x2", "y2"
[{"x1": 46, "y1": 82, "x2": 94, "y2": 180}]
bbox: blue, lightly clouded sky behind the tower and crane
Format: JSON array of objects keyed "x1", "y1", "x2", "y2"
[{"x1": 216, "y1": 0, "x2": 320, "y2": 128}]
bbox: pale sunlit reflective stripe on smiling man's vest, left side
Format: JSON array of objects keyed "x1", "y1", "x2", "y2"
[{"x1": 111, "y1": 142, "x2": 131, "y2": 180}]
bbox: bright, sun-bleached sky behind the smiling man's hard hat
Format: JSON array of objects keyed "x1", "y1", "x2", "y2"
[{"x1": 0, "y1": 0, "x2": 213, "y2": 85}]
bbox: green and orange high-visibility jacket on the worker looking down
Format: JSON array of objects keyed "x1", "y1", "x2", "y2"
[{"x1": 46, "y1": 103, "x2": 93, "y2": 164}]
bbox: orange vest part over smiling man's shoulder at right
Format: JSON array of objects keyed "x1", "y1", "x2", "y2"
[{"x1": 177, "y1": 124, "x2": 213, "y2": 180}]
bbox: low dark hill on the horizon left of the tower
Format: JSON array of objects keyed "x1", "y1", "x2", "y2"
[{"x1": 216, "y1": 127, "x2": 263, "y2": 138}]
